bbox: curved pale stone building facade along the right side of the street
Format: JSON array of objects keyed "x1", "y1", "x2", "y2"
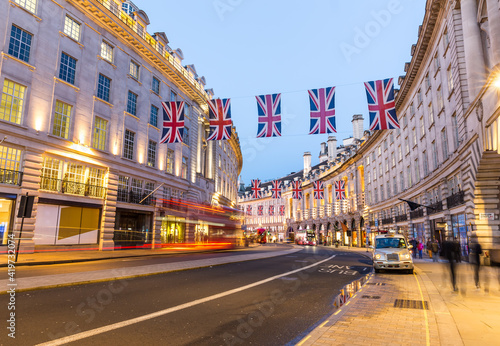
[{"x1": 240, "y1": 0, "x2": 500, "y2": 255}]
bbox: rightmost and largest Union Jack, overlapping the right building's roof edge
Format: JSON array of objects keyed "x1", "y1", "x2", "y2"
[{"x1": 365, "y1": 78, "x2": 399, "y2": 131}]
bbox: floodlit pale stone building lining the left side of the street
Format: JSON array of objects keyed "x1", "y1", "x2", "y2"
[{"x1": 0, "y1": 0, "x2": 242, "y2": 252}]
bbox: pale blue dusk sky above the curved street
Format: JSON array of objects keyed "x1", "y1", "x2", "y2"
[{"x1": 141, "y1": 0, "x2": 426, "y2": 185}]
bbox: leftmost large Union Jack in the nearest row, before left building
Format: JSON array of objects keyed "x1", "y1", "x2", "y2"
[{"x1": 160, "y1": 101, "x2": 184, "y2": 143}]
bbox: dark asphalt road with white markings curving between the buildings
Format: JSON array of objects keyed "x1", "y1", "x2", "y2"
[{"x1": 0, "y1": 247, "x2": 371, "y2": 345}]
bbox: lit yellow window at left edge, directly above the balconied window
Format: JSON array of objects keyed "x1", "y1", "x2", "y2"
[{"x1": 0, "y1": 79, "x2": 26, "y2": 124}]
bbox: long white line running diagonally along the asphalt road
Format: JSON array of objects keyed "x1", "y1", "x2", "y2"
[{"x1": 37, "y1": 255, "x2": 336, "y2": 346}]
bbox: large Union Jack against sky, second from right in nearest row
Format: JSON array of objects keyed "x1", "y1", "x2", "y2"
[{"x1": 309, "y1": 87, "x2": 337, "y2": 135}]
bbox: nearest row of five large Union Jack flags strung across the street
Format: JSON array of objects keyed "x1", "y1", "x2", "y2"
[{"x1": 160, "y1": 78, "x2": 399, "y2": 143}]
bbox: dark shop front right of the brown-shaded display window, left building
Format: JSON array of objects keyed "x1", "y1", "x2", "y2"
[{"x1": 113, "y1": 208, "x2": 153, "y2": 248}]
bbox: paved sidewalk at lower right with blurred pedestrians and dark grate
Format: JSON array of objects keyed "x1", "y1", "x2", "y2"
[{"x1": 297, "y1": 248, "x2": 500, "y2": 346}]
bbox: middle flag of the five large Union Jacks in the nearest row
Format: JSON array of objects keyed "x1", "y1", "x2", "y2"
[{"x1": 255, "y1": 94, "x2": 281, "y2": 138}]
